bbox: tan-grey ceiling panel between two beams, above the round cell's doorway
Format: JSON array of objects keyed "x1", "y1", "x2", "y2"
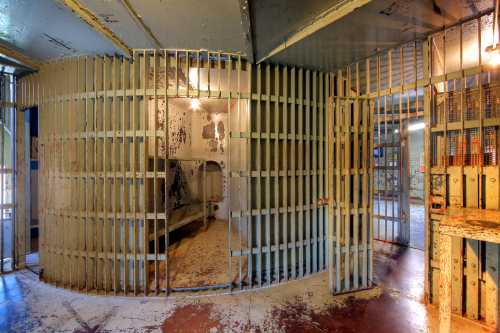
[{"x1": 129, "y1": 0, "x2": 246, "y2": 55}]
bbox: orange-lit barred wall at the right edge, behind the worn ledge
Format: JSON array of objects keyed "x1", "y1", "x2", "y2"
[{"x1": 427, "y1": 14, "x2": 500, "y2": 325}]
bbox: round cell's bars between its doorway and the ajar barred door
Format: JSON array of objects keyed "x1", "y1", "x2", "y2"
[{"x1": 231, "y1": 64, "x2": 330, "y2": 288}]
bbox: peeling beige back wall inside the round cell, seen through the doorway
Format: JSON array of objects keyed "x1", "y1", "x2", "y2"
[{"x1": 149, "y1": 94, "x2": 247, "y2": 219}]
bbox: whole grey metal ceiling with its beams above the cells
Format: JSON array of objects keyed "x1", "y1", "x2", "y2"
[{"x1": 0, "y1": 0, "x2": 493, "y2": 70}]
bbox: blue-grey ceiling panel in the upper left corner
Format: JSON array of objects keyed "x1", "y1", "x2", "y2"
[{"x1": 0, "y1": 0, "x2": 120, "y2": 60}]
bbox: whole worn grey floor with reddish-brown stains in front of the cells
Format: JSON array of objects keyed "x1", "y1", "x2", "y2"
[{"x1": 0, "y1": 243, "x2": 491, "y2": 333}]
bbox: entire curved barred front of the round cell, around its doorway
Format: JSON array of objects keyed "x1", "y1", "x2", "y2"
[{"x1": 13, "y1": 50, "x2": 354, "y2": 294}]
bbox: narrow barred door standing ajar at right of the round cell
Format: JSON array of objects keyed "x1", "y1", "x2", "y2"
[{"x1": 328, "y1": 78, "x2": 373, "y2": 293}]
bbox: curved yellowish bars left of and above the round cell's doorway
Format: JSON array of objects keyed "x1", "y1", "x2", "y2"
[{"x1": 18, "y1": 50, "x2": 254, "y2": 295}]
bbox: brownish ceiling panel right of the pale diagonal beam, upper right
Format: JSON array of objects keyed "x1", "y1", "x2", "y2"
[{"x1": 270, "y1": 0, "x2": 493, "y2": 70}]
